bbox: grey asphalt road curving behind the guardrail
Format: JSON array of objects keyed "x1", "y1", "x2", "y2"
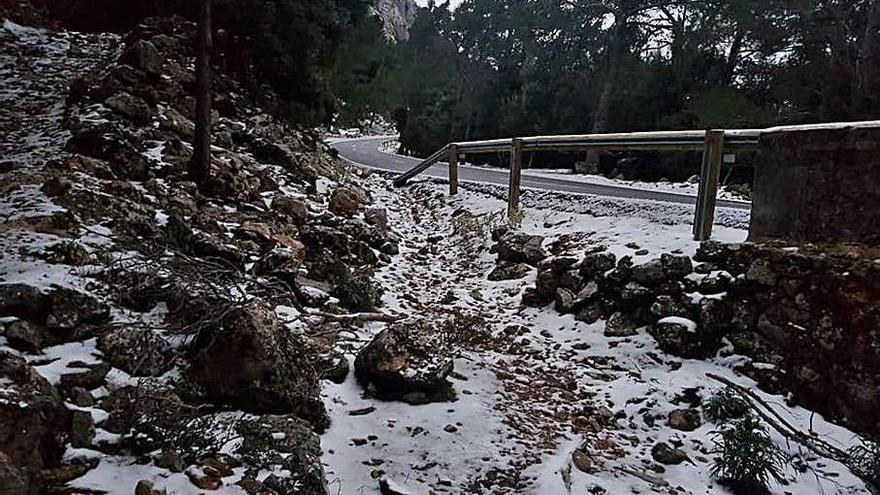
[{"x1": 331, "y1": 138, "x2": 751, "y2": 210}]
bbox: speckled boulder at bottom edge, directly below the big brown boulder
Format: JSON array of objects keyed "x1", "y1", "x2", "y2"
[{"x1": 236, "y1": 415, "x2": 327, "y2": 495}]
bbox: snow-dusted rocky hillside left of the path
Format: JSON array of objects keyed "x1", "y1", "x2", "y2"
[{"x1": 0, "y1": 15, "x2": 397, "y2": 494}]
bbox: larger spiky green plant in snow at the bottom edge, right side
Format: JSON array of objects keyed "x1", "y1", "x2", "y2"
[{"x1": 709, "y1": 416, "x2": 788, "y2": 495}]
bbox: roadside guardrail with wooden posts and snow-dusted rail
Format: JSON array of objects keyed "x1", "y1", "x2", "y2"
[{"x1": 394, "y1": 121, "x2": 880, "y2": 241}]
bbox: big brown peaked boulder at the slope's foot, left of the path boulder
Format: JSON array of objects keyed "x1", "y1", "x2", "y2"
[{"x1": 186, "y1": 300, "x2": 329, "y2": 430}]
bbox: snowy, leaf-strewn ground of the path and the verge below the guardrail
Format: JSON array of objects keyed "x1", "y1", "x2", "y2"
[{"x1": 322, "y1": 171, "x2": 867, "y2": 494}]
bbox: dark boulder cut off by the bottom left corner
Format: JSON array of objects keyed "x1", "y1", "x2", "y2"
[{"x1": 0, "y1": 350, "x2": 70, "y2": 495}]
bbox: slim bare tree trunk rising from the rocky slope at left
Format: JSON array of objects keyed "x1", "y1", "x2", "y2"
[{"x1": 189, "y1": 0, "x2": 213, "y2": 187}]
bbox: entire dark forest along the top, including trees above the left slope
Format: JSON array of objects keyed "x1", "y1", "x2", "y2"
[{"x1": 12, "y1": 0, "x2": 880, "y2": 181}]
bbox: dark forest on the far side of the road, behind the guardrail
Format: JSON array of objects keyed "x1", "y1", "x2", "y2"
[{"x1": 333, "y1": 0, "x2": 880, "y2": 166}]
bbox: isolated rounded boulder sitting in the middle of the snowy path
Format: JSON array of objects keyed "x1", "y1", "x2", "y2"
[{"x1": 354, "y1": 319, "x2": 453, "y2": 395}]
